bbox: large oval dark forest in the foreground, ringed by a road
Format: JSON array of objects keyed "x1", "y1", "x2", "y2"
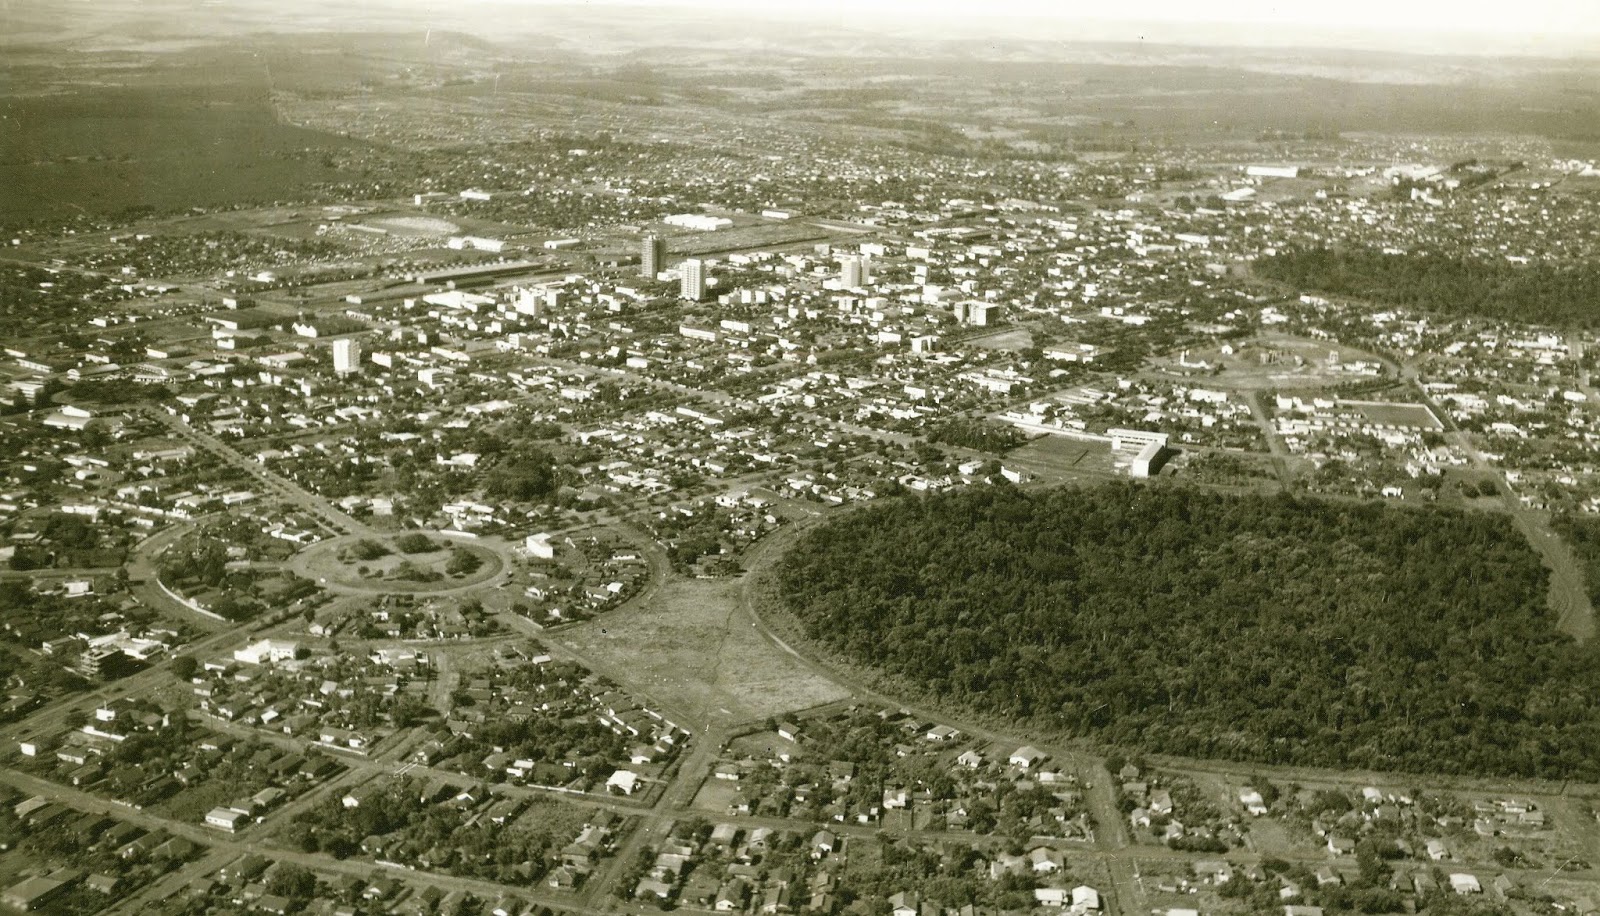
[{"x1": 776, "y1": 484, "x2": 1600, "y2": 780}]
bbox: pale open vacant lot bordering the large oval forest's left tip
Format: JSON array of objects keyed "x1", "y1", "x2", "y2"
[{"x1": 549, "y1": 580, "x2": 846, "y2": 724}]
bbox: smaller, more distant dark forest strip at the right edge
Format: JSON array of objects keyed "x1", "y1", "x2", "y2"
[{"x1": 1254, "y1": 248, "x2": 1600, "y2": 328}]
